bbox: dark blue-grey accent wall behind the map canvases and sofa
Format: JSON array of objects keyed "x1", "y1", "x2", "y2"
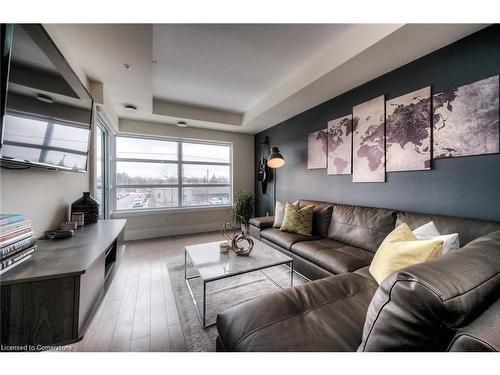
[{"x1": 255, "y1": 24, "x2": 500, "y2": 221}]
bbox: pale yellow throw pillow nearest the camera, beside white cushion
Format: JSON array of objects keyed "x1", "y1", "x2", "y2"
[{"x1": 369, "y1": 224, "x2": 443, "y2": 284}]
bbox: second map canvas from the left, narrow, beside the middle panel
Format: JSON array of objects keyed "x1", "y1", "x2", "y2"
[{"x1": 327, "y1": 115, "x2": 352, "y2": 175}]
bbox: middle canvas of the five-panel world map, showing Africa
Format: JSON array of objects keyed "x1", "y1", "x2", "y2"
[{"x1": 352, "y1": 95, "x2": 385, "y2": 182}]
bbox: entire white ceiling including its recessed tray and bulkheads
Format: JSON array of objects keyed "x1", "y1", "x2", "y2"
[{"x1": 44, "y1": 24, "x2": 487, "y2": 133}]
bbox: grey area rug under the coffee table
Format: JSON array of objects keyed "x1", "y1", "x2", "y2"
[{"x1": 167, "y1": 244, "x2": 306, "y2": 352}]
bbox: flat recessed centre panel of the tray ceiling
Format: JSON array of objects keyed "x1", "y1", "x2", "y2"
[{"x1": 153, "y1": 24, "x2": 353, "y2": 113}]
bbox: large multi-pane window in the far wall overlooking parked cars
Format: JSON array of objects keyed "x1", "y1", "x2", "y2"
[{"x1": 115, "y1": 136, "x2": 232, "y2": 210}]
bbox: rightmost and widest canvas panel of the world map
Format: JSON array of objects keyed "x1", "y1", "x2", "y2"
[{"x1": 433, "y1": 75, "x2": 500, "y2": 159}]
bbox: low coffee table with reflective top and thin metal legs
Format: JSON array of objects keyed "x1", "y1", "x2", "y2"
[{"x1": 184, "y1": 239, "x2": 293, "y2": 328}]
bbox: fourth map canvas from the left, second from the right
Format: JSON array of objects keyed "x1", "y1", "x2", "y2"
[{"x1": 385, "y1": 86, "x2": 431, "y2": 172}]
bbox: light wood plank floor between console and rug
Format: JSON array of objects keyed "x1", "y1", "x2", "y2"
[{"x1": 72, "y1": 233, "x2": 218, "y2": 351}]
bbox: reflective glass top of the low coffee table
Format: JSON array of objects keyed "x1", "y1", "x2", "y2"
[{"x1": 185, "y1": 240, "x2": 293, "y2": 281}]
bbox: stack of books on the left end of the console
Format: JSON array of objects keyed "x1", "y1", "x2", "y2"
[{"x1": 0, "y1": 214, "x2": 36, "y2": 274}]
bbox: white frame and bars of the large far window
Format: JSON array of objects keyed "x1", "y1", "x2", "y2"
[{"x1": 112, "y1": 133, "x2": 233, "y2": 216}]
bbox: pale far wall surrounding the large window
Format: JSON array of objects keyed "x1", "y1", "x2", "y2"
[{"x1": 113, "y1": 119, "x2": 254, "y2": 240}]
